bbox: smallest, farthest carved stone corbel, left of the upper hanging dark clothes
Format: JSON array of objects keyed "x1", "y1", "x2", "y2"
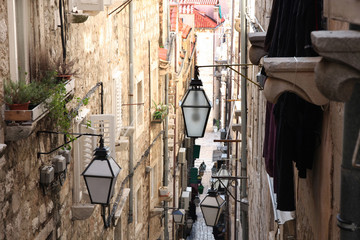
[{"x1": 248, "y1": 32, "x2": 267, "y2": 65}]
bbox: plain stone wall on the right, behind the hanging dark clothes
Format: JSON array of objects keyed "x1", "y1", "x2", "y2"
[{"x1": 247, "y1": 0, "x2": 348, "y2": 239}]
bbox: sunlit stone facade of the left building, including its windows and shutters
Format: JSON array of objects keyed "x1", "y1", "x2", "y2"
[{"x1": 0, "y1": 0, "x2": 195, "y2": 239}]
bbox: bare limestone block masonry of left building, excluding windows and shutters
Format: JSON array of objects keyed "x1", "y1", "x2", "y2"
[{"x1": 0, "y1": 0, "x2": 163, "y2": 239}]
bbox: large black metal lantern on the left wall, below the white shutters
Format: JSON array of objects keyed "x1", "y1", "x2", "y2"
[{"x1": 82, "y1": 138, "x2": 121, "y2": 206}]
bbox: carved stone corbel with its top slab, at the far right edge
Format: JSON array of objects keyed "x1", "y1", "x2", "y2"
[{"x1": 311, "y1": 30, "x2": 360, "y2": 102}]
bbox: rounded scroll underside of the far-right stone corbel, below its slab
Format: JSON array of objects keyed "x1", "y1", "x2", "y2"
[{"x1": 315, "y1": 59, "x2": 360, "y2": 102}]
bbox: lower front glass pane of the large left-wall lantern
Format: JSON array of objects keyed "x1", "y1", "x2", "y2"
[{"x1": 85, "y1": 176, "x2": 112, "y2": 204}]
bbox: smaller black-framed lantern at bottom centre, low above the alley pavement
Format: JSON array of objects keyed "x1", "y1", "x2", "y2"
[{"x1": 200, "y1": 189, "x2": 225, "y2": 227}]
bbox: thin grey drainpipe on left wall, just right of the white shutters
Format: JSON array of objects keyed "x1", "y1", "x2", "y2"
[{"x1": 127, "y1": 1, "x2": 134, "y2": 230}]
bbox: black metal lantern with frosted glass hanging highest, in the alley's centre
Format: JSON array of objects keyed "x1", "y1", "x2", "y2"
[{"x1": 180, "y1": 68, "x2": 211, "y2": 138}]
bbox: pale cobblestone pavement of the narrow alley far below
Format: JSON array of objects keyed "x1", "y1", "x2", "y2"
[{"x1": 187, "y1": 132, "x2": 220, "y2": 240}]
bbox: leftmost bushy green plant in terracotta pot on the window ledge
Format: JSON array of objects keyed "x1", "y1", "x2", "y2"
[{"x1": 4, "y1": 79, "x2": 32, "y2": 110}]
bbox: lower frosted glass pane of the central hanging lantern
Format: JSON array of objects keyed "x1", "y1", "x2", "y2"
[{"x1": 183, "y1": 106, "x2": 210, "y2": 137}]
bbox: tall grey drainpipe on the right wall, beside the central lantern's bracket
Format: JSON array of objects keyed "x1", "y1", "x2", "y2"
[{"x1": 240, "y1": 1, "x2": 249, "y2": 240}]
